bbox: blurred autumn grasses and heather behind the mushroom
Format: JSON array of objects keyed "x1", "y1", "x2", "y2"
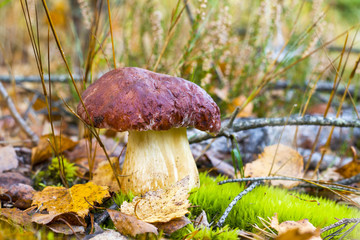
[{"x1": 0, "y1": 0, "x2": 360, "y2": 138}]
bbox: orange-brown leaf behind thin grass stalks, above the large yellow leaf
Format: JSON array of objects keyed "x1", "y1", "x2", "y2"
[{"x1": 31, "y1": 134, "x2": 77, "y2": 165}]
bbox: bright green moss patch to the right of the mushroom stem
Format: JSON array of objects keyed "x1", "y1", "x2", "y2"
[{"x1": 189, "y1": 174, "x2": 360, "y2": 238}]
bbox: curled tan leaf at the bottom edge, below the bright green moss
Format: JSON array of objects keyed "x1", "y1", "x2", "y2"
[{"x1": 270, "y1": 213, "x2": 321, "y2": 240}]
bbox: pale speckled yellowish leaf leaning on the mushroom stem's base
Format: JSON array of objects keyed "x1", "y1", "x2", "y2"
[{"x1": 121, "y1": 176, "x2": 190, "y2": 223}]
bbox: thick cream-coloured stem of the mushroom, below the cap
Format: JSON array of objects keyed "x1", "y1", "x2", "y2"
[{"x1": 120, "y1": 128, "x2": 199, "y2": 194}]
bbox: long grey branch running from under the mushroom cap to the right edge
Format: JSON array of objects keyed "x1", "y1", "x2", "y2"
[{"x1": 189, "y1": 116, "x2": 360, "y2": 143}]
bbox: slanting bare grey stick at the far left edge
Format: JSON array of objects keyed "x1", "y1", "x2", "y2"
[{"x1": 0, "y1": 82, "x2": 39, "y2": 144}]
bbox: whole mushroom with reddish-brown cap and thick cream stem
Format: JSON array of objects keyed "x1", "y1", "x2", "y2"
[{"x1": 77, "y1": 67, "x2": 221, "y2": 194}]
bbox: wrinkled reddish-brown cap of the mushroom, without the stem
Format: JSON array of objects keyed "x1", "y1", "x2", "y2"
[{"x1": 77, "y1": 67, "x2": 221, "y2": 133}]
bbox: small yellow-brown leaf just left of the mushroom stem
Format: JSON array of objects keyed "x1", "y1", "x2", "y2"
[{"x1": 92, "y1": 157, "x2": 120, "y2": 192}]
